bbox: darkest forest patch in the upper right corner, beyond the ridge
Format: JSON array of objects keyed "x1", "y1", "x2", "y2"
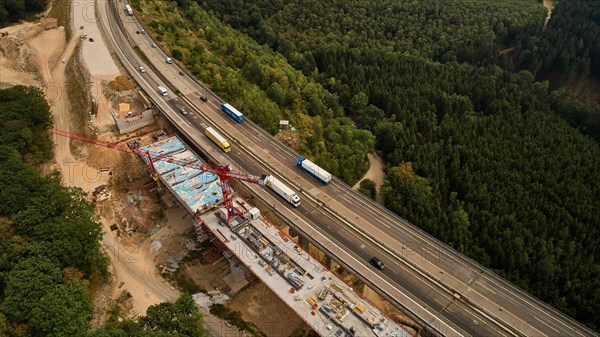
[{"x1": 515, "y1": 0, "x2": 600, "y2": 139}]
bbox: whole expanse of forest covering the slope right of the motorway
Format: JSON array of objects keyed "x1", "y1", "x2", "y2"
[{"x1": 145, "y1": 0, "x2": 600, "y2": 329}]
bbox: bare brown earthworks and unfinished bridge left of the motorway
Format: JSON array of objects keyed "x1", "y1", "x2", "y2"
[{"x1": 0, "y1": 2, "x2": 417, "y2": 337}]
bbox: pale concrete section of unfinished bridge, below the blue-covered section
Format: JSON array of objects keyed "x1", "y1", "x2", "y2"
[{"x1": 196, "y1": 202, "x2": 410, "y2": 337}]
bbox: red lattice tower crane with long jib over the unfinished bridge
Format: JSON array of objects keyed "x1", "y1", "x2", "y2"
[{"x1": 48, "y1": 129, "x2": 264, "y2": 224}]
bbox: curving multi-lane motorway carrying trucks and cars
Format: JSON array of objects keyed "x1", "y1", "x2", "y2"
[{"x1": 98, "y1": 1, "x2": 595, "y2": 336}]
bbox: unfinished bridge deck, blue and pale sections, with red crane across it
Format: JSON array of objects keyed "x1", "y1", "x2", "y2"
[{"x1": 51, "y1": 126, "x2": 410, "y2": 337}]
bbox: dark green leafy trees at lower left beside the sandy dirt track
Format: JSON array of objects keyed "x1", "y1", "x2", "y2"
[{"x1": 0, "y1": 86, "x2": 206, "y2": 337}]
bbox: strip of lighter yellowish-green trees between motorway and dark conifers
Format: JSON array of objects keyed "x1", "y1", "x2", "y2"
[{"x1": 144, "y1": 1, "x2": 375, "y2": 184}]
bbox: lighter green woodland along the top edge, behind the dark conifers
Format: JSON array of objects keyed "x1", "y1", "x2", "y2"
[{"x1": 195, "y1": 0, "x2": 546, "y2": 66}]
